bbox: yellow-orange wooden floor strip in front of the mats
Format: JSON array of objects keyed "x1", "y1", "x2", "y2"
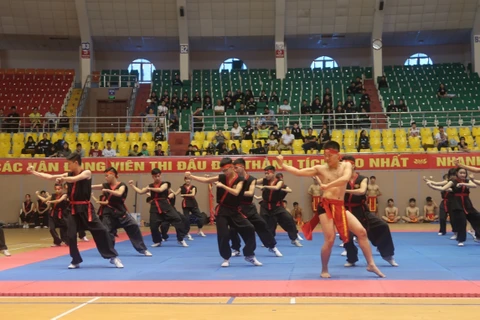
[{"x1": 0, "y1": 297, "x2": 480, "y2": 320}]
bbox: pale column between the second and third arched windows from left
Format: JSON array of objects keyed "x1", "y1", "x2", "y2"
[{"x1": 275, "y1": 0, "x2": 287, "y2": 79}]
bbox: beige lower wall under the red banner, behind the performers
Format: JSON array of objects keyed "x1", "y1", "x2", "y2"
[{"x1": 0, "y1": 169, "x2": 480, "y2": 222}]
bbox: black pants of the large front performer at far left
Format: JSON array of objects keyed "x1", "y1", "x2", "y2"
[{"x1": 66, "y1": 204, "x2": 118, "y2": 264}]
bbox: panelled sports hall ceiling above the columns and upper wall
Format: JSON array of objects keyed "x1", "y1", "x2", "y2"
[{"x1": 0, "y1": 0, "x2": 480, "y2": 51}]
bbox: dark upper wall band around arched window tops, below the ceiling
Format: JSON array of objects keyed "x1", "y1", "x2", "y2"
[{"x1": 0, "y1": 44, "x2": 471, "y2": 82}]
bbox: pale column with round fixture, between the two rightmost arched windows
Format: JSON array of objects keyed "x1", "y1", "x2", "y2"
[{"x1": 370, "y1": 0, "x2": 386, "y2": 83}]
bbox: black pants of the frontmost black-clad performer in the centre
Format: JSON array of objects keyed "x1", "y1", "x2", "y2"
[{"x1": 216, "y1": 205, "x2": 257, "y2": 260}]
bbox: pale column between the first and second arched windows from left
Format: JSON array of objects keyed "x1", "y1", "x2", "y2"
[{"x1": 177, "y1": 0, "x2": 190, "y2": 81}]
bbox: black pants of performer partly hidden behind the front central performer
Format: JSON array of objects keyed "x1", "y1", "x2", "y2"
[{"x1": 230, "y1": 204, "x2": 277, "y2": 251}]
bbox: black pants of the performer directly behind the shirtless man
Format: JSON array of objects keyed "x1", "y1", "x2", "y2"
[{"x1": 343, "y1": 207, "x2": 395, "y2": 263}]
